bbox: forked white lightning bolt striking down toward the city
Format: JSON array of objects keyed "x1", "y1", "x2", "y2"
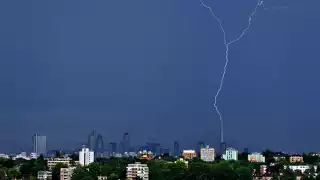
[{"x1": 200, "y1": 0, "x2": 264, "y2": 143}]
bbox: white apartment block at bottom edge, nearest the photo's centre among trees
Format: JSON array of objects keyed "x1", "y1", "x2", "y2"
[{"x1": 127, "y1": 162, "x2": 149, "y2": 180}]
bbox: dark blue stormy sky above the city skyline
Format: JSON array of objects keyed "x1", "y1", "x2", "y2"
[{"x1": 0, "y1": 0, "x2": 320, "y2": 151}]
